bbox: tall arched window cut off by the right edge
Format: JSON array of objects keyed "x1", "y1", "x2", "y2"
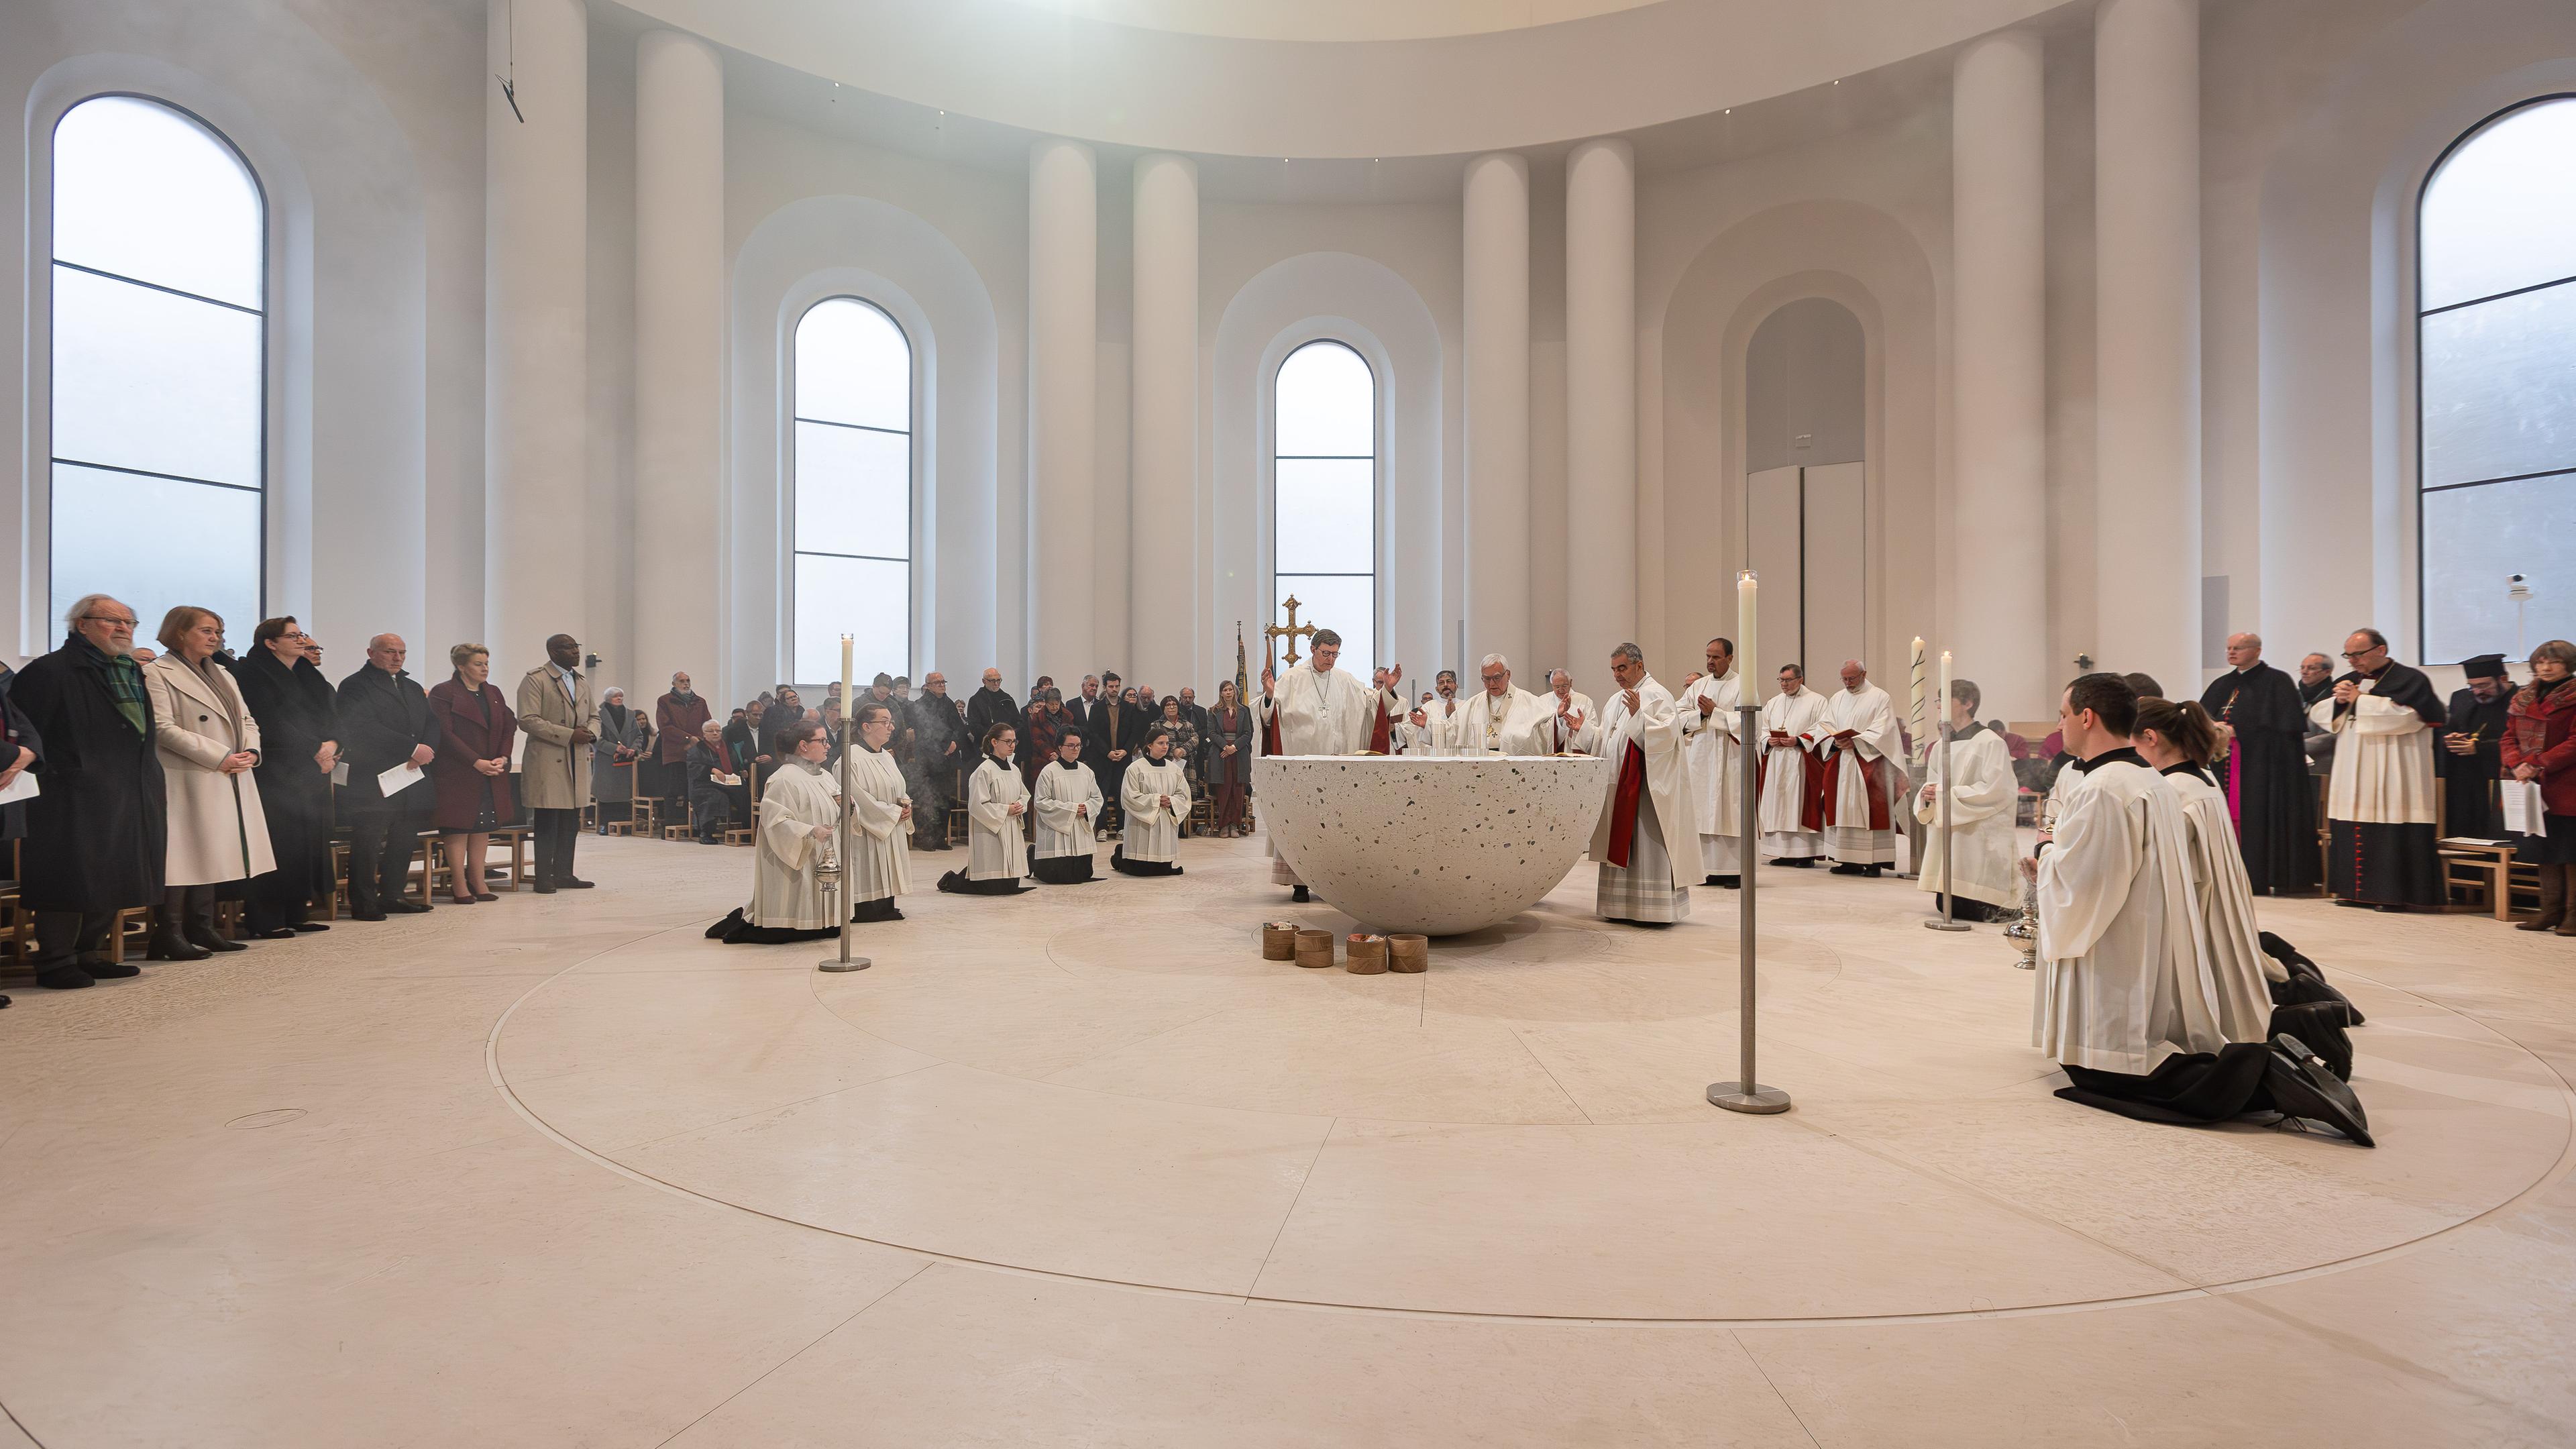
[{"x1": 2416, "y1": 95, "x2": 2576, "y2": 663}]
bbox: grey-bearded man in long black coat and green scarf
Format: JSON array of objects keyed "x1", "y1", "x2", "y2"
[{"x1": 10, "y1": 593, "x2": 170, "y2": 990}]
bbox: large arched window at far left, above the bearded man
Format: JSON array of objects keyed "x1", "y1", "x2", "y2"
[{"x1": 49, "y1": 95, "x2": 268, "y2": 629}]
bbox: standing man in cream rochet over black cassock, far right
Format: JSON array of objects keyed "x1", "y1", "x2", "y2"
[{"x1": 2310, "y1": 629, "x2": 2445, "y2": 910}]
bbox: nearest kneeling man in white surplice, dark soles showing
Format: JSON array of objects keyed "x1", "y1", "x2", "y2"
[{"x1": 2022, "y1": 673, "x2": 2370, "y2": 1147}]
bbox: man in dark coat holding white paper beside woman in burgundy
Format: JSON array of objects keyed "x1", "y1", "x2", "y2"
[{"x1": 340, "y1": 634, "x2": 438, "y2": 920}]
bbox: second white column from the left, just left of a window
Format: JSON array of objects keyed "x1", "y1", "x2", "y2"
[{"x1": 633, "y1": 31, "x2": 727, "y2": 709}]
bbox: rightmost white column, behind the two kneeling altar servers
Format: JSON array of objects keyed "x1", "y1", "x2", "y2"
[{"x1": 2092, "y1": 0, "x2": 2200, "y2": 699}]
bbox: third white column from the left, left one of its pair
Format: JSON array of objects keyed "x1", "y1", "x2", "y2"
[{"x1": 1028, "y1": 140, "x2": 1100, "y2": 684}]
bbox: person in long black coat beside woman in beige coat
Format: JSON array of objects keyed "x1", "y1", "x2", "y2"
[{"x1": 232, "y1": 616, "x2": 340, "y2": 941}]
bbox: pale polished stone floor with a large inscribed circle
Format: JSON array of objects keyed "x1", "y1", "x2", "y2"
[{"x1": 0, "y1": 824, "x2": 2576, "y2": 1449}]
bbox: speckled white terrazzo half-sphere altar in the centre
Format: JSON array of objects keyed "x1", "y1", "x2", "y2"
[{"x1": 1252, "y1": 755, "x2": 1610, "y2": 936}]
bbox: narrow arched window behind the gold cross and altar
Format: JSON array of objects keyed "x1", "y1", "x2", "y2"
[{"x1": 1270, "y1": 340, "x2": 1378, "y2": 678}]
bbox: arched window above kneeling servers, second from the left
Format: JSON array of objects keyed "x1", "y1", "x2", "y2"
[{"x1": 788, "y1": 297, "x2": 912, "y2": 684}]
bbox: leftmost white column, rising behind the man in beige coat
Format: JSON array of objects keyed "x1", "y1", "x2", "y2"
[{"x1": 482, "y1": 0, "x2": 592, "y2": 688}]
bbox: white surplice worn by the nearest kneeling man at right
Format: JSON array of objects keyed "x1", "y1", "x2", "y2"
[{"x1": 2030, "y1": 753, "x2": 2229, "y2": 1075}]
